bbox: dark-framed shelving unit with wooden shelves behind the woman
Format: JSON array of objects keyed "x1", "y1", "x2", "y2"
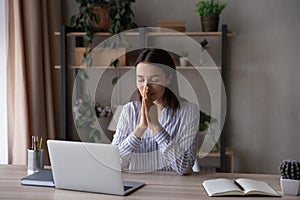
[{"x1": 54, "y1": 25, "x2": 235, "y2": 171}]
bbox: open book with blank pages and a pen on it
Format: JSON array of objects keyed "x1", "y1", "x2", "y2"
[{"x1": 202, "y1": 178, "x2": 281, "y2": 197}]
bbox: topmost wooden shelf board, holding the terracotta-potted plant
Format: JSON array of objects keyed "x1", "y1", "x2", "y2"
[{"x1": 54, "y1": 32, "x2": 236, "y2": 37}]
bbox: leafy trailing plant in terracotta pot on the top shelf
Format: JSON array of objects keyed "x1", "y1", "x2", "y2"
[{"x1": 70, "y1": 0, "x2": 137, "y2": 58}]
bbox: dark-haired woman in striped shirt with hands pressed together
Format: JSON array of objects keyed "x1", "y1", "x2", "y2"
[{"x1": 112, "y1": 49, "x2": 199, "y2": 175}]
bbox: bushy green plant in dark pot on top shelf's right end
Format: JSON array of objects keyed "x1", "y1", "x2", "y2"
[{"x1": 196, "y1": 0, "x2": 226, "y2": 32}]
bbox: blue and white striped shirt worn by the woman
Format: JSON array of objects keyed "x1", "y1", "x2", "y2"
[{"x1": 112, "y1": 101, "x2": 199, "y2": 175}]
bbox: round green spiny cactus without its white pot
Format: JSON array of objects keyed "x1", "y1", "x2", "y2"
[{"x1": 280, "y1": 160, "x2": 300, "y2": 180}]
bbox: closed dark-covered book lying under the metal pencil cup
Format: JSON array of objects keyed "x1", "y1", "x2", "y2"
[{"x1": 21, "y1": 169, "x2": 55, "y2": 187}]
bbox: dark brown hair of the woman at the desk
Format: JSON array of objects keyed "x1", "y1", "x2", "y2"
[{"x1": 135, "y1": 48, "x2": 180, "y2": 111}]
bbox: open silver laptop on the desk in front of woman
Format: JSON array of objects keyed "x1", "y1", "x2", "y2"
[{"x1": 47, "y1": 140, "x2": 145, "y2": 195}]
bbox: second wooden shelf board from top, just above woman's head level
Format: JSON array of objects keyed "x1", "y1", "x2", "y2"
[{"x1": 54, "y1": 65, "x2": 222, "y2": 70}]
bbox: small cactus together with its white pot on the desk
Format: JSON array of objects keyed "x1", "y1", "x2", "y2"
[{"x1": 279, "y1": 160, "x2": 300, "y2": 196}]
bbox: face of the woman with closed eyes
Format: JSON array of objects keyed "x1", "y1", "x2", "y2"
[{"x1": 136, "y1": 62, "x2": 170, "y2": 104}]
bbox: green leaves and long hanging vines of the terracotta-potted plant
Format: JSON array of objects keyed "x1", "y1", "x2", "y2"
[{"x1": 70, "y1": 0, "x2": 137, "y2": 81}]
